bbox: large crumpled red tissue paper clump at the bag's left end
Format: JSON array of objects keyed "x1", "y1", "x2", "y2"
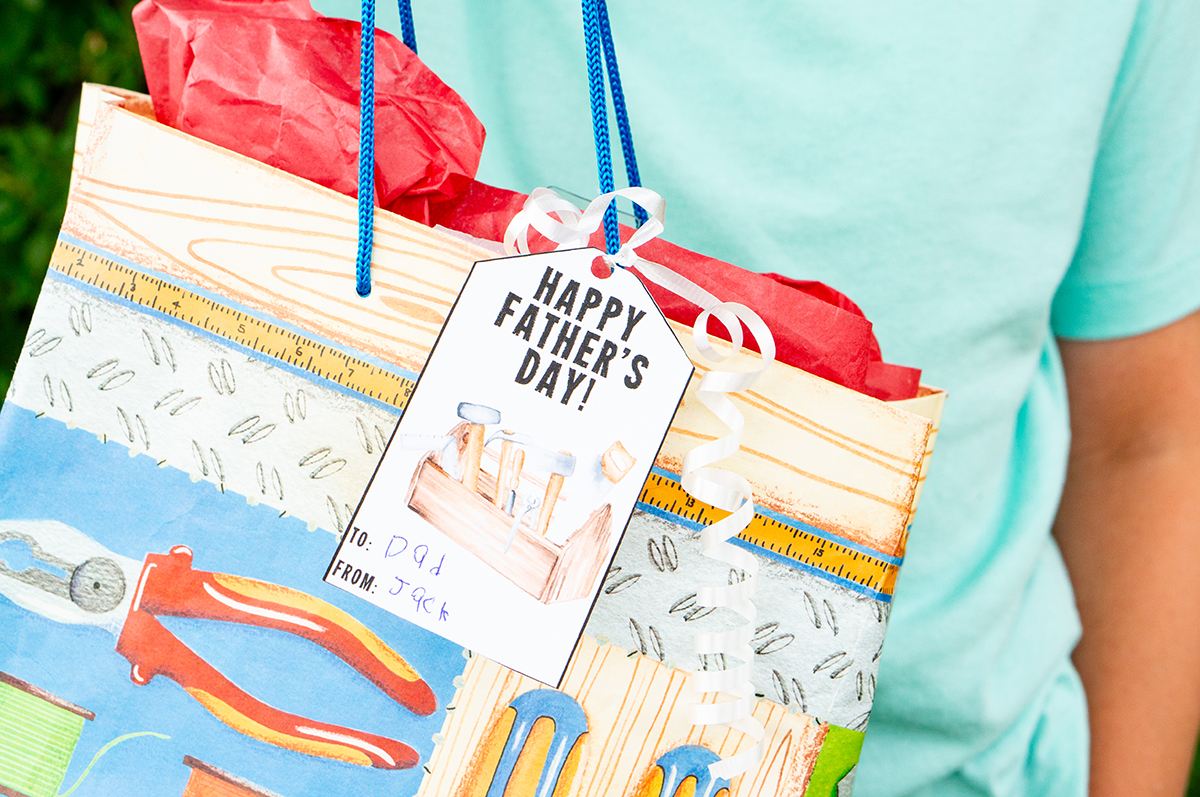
[{"x1": 133, "y1": 0, "x2": 484, "y2": 221}]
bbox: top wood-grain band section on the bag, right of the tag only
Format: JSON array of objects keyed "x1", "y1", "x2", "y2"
[{"x1": 656, "y1": 345, "x2": 931, "y2": 556}]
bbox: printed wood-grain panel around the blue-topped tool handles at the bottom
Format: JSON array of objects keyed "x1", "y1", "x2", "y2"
[{"x1": 418, "y1": 636, "x2": 826, "y2": 797}]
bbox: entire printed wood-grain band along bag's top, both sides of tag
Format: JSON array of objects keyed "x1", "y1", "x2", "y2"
[{"x1": 64, "y1": 88, "x2": 931, "y2": 553}]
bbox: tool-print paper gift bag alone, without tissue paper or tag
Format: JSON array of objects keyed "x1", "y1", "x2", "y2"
[{"x1": 0, "y1": 86, "x2": 942, "y2": 797}]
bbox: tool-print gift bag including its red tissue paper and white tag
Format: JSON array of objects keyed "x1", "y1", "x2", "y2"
[{"x1": 7, "y1": 0, "x2": 942, "y2": 777}]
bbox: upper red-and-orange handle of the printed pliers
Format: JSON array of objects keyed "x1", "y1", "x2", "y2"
[{"x1": 130, "y1": 546, "x2": 437, "y2": 717}]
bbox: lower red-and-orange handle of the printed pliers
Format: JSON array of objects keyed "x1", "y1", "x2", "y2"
[{"x1": 116, "y1": 610, "x2": 420, "y2": 769}]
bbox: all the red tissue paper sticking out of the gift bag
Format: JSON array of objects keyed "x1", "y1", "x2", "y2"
[{"x1": 133, "y1": 0, "x2": 920, "y2": 401}]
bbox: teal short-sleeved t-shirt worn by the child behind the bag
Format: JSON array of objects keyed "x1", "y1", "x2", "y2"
[{"x1": 318, "y1": 0, "x2": 1200, "y2": 797}]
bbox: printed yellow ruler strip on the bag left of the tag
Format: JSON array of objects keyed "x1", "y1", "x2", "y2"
[{"x1": 50, "y1": 240, "x2": 413, "y2": 409}]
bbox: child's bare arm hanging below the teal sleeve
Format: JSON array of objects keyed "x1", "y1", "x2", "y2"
[{"x1": 1055, "y1": 313, "x2": 1200, "y2": 797}]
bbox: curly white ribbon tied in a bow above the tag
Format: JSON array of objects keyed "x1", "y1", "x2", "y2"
[{"x1": 504, "y1": 187, "x2": 775, "y2": 779}]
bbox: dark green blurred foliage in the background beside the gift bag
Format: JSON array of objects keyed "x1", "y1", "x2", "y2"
[{"x1": 0, "y1": 0, "x2": 1200, "y2": 797}]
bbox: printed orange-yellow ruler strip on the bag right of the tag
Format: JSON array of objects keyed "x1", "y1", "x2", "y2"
[{"x1": 637, "y1": 473, "x2": 899, "y2": 595}]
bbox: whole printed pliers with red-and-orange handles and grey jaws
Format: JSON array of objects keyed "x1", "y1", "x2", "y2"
[{"x1": 0, "y1": 521, "x2": 437, "y2": 769}]
